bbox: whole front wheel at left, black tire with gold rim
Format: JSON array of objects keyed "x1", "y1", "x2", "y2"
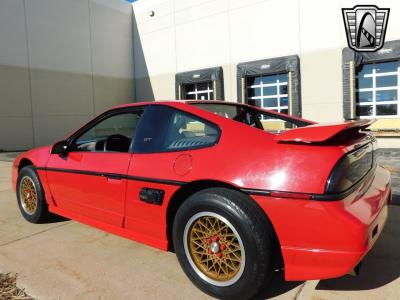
[{"x1": 17, "y1": 166, "x2": 51, "y2": 223}]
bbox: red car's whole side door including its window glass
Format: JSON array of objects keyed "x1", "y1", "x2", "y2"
[{"x1": 46, "y1": 109, "x2": 142, "y2": 227}]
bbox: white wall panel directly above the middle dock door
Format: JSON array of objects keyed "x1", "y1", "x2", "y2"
[{"x1": 230, "y1": 0, "x2": 299, "y2": 62}]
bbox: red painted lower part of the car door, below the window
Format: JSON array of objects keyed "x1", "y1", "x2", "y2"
[{"x1": 46, "y1": 152, "x2": 132, "y2": 227}]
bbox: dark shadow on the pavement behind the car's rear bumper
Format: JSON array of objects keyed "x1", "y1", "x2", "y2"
[{"x1": 316, "y1": 203, "x2": 400, "y2": 291}]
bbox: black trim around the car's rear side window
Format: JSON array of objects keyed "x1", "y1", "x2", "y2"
[{"x1": 130, "y1": 100, "x2": 222, "y2": 155}]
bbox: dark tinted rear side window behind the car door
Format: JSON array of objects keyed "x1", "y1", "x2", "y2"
[{"x1": 133, "y1": 105, "x2": 219, "y2": 153}]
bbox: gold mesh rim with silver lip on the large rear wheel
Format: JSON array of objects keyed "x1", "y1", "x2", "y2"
[{"x1": 185, "y1": 212, "x2": 245, "y2": 286}]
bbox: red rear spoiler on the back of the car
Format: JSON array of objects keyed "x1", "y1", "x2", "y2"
[{"x1": 274, "y1": 120, "x2": 375, "y2": 143}]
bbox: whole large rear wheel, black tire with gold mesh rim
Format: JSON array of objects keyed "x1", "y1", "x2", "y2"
[{"x1": 173, "y1": 188, "x2": 273, "y2": 299}]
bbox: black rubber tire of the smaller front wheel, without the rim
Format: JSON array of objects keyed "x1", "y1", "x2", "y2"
[{"x1": 17, "y1": 166, "x2": 51, "y2": 223}]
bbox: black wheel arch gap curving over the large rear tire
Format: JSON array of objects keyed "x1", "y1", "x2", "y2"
[{"x1": 166, "y1": 180, "x2": 284, "y2": 268}]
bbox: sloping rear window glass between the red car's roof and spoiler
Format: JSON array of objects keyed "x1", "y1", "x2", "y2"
[{"x1": 190, "y1": 103, "x2": 311, "y2": 133}]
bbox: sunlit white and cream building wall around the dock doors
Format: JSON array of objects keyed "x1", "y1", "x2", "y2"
[{"x1": 133, "y1": 0, "x2": 400, "y2": 147}]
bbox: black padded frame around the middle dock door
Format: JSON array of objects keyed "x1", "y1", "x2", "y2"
[{"x1": 237, "y1": 55, "x2": 301, "y2": 117}]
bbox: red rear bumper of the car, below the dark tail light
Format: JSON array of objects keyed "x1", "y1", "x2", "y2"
[{"x1": 254, "y1": 167, "x2": 391, "y2": 280}]
